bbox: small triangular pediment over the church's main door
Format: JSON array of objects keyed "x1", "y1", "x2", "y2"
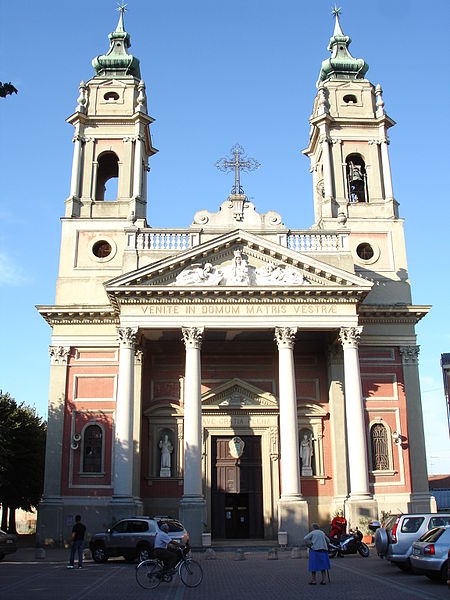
[{"x1": 202, "y1": 378, "x2": 278, "y2": 410}]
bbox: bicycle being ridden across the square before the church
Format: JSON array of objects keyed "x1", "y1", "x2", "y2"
[{"x1": 136, "y1": 548, "x2": 203, "y2": 590}]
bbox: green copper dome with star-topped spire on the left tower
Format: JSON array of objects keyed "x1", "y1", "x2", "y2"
[{"x1": 92, "y1": 6, "x2": 141, "y2": 79}]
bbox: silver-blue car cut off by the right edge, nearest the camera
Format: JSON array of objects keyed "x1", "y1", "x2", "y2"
[{"x1": 410, "y1": 526, "x2": 450, "y2": 583}]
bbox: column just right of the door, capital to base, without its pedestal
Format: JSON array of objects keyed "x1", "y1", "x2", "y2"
[{"x1": 275, "y1": 327, "x2": 301, "y2": 499}]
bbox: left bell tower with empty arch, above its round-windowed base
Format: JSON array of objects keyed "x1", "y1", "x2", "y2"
[{"x1": 65, "y1": 6, "x2": 156, "y2": 222}]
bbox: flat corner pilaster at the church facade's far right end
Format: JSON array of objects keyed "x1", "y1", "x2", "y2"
[{"x1": 399, "y1": 346, "x2": 430, "y2": 512}]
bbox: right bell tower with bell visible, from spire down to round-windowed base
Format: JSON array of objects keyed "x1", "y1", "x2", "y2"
[{"x1": 303, "y1": 9, "x2": 411, "y2": 304}]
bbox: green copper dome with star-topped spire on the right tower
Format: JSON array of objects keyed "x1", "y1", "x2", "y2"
[{"x1": 317, "y1": 9, "x2": 369, "y2": 87}]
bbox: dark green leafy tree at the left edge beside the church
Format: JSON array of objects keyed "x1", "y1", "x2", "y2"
[{"x1": 0, "y1": 392, "x2": 47, "y2": 533}]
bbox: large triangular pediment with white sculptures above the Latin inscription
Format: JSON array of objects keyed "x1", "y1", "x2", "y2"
[{"x1": 106, "y1": 230, "x2": 372, "y2": 295}]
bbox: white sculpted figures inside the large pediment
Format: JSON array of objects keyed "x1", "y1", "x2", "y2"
[{"x1": 175, "y1": 250, "x2": 310, "y2": 286}]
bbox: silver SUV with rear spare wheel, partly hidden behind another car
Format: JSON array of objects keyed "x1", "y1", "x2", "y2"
[{"x1": 375, "y1": 513, "x2": 450, "y2": 570}]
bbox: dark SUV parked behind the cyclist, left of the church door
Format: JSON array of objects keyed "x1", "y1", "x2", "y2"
[{"x1": 89, "y1": 517, "x2": 189, "y2": 563}]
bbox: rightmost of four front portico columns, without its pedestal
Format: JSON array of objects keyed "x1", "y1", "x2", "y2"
[{"x1": 339, "y1": 327, "x2": 370, "y2": 498}]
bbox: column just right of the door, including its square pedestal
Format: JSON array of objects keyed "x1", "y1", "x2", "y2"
[{"x1": 275, "y1": 327, "x2": 309, "y2": 546}]
